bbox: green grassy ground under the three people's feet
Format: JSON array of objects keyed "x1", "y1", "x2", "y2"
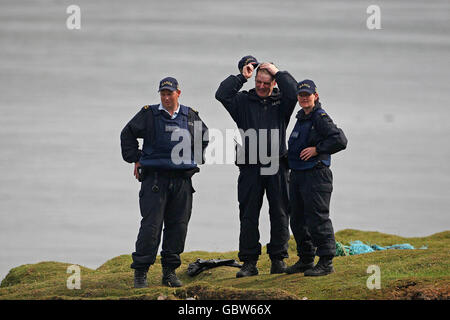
[{"x1": 0, "y1": 229, "x2": 450, "y2": 300}]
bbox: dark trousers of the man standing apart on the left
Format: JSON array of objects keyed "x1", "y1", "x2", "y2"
[{"x1": 131, "y1": 174, "x2": 194, "y2": 270}]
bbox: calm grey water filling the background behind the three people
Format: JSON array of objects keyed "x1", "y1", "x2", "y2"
[{"x1": 0, "y1": 0, "x2": 450, "y2": 279}]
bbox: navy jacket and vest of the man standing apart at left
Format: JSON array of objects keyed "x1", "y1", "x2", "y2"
[{"x1": 120, "y1": 105, "x2": 208, "y2": 170}]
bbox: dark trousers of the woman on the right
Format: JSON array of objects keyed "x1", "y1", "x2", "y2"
[{"x1": 289, "y1": 166, "x2": 336, "y2": 258}]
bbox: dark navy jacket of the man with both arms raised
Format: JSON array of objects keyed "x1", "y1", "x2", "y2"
[{"x1": 216, "y1": 71, "x2": 297, "y2": 164}]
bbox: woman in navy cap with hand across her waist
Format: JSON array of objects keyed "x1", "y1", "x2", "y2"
[{"x1": 286, "y1": 79, "x2": 347, "y2": 276}]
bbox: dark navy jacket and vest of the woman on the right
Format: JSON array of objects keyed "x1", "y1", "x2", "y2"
[{"x1": 288, "y1": 102, "x2": 347, "y2": 170}]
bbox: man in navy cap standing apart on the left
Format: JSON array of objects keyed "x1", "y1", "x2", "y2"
[{"x1": 120, "y1": 77, "x2": 208, "y2": 288}]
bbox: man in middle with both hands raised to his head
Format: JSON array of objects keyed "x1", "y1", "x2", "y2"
[{"x1": 216, "y1": 56, "x2": 297, "y2": 278}]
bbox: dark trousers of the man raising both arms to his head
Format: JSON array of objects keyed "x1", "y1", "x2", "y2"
[{"x1": 238, "y1": 162, "x2": 289, "y2": 261}]
